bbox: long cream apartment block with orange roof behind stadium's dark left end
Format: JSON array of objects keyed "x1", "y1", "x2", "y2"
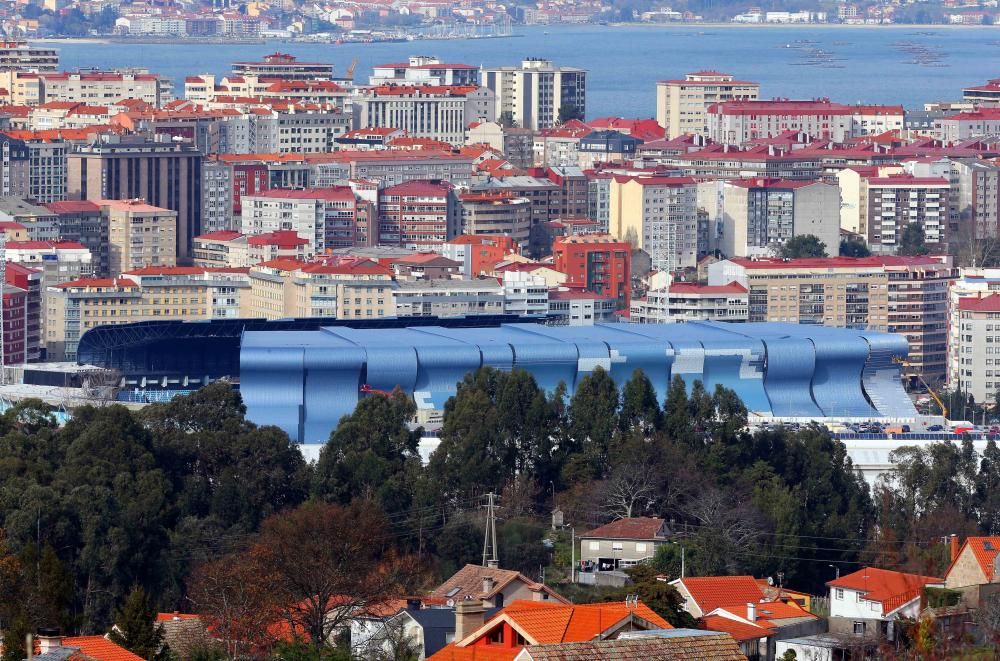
[{"x1": 44, "y1": 267, "x2": 249, "y2": 361}]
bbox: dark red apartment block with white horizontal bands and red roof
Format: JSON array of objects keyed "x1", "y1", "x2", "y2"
[{"x1": 377, "y1": 180, "x2": 461, "y2": 250}]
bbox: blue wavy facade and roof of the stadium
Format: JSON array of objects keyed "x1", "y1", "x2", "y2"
[{"x1": 239, "y1": 322, "x2": 916, "y2": 444}]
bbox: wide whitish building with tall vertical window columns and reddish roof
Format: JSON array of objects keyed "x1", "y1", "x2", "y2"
[{"x1": 352, "y1": 85, "x2": 496, "y2": 145}]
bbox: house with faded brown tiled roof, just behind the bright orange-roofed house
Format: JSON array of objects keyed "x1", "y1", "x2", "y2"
[{"x1": 427, "y1": 565, "x2": 569, "y2": 608}]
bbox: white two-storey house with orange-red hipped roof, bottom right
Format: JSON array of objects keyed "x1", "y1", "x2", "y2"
[{"x1": 827, "y1": 567, "x2": 944, "y2": 640}]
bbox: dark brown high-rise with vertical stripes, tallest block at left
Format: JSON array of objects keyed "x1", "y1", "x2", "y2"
[{"x1": 67, "y1": 139, "x2": 202, "y2": 263}]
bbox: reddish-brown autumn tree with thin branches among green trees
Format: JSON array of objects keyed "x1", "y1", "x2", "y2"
[{"x1": 252, "y1": 500, "x2": 412, "y2": 648}]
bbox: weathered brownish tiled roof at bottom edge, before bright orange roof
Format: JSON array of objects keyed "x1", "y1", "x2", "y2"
[{"x1": 514, "y1": 629, "x2": 746, "y2": 661}]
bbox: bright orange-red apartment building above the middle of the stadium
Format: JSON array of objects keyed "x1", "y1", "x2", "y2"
[{"x1": 552, "y1": 234, "x2": 632, "y2": 309}]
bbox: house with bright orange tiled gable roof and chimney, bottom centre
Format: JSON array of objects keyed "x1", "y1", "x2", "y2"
[{"x1": 430, "y1": 599, "x2": 672, "y2": 661}]
